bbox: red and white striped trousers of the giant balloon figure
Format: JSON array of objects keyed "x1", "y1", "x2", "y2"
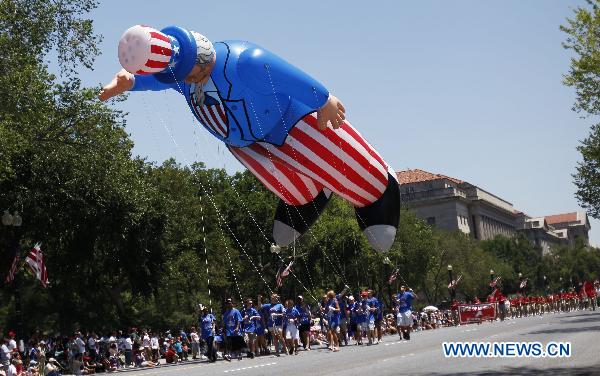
[{"x1": 229, "y1": 113, "x2": 388, "y2": 207}]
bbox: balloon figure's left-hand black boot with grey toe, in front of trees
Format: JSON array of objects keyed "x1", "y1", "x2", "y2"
[{"x1": 273, "y1": 188, "x2": 331, "y2": 247}]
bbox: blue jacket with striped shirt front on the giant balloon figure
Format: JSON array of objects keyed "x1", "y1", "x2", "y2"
[{"x1": 131, "y1": 40, "x2": 329, "y2": 147}]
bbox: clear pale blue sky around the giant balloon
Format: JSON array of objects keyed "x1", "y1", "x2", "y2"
[{"x1": 81, "y1": 0, "x2": 600, "y2": 245}]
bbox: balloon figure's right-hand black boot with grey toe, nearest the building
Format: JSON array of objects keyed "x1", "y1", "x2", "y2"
[{"x1": 355, "y1": 172, "x2": 400, "y2": 252}]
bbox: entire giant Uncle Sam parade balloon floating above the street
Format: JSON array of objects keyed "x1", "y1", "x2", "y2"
[{"x1": 99, "y1": 25, "x2": 400, "y2": 251}]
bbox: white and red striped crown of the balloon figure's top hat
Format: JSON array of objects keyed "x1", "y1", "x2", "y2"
[{"x1": 119, "y1": 25, "x2": 175, "y2": 74}]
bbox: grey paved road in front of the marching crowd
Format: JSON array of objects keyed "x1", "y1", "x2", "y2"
[{"x1": 124, "y1": 311, "x2": 600, "y2": 376}]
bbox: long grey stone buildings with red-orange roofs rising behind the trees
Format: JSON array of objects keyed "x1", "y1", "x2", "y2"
[{"x1": 397, "y1": 169, "x2": 590, "y2": 253}]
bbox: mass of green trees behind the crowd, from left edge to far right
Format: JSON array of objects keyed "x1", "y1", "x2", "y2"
[{"x1": 0, "y1": 0, "x2": 598, "y2": 333}]
